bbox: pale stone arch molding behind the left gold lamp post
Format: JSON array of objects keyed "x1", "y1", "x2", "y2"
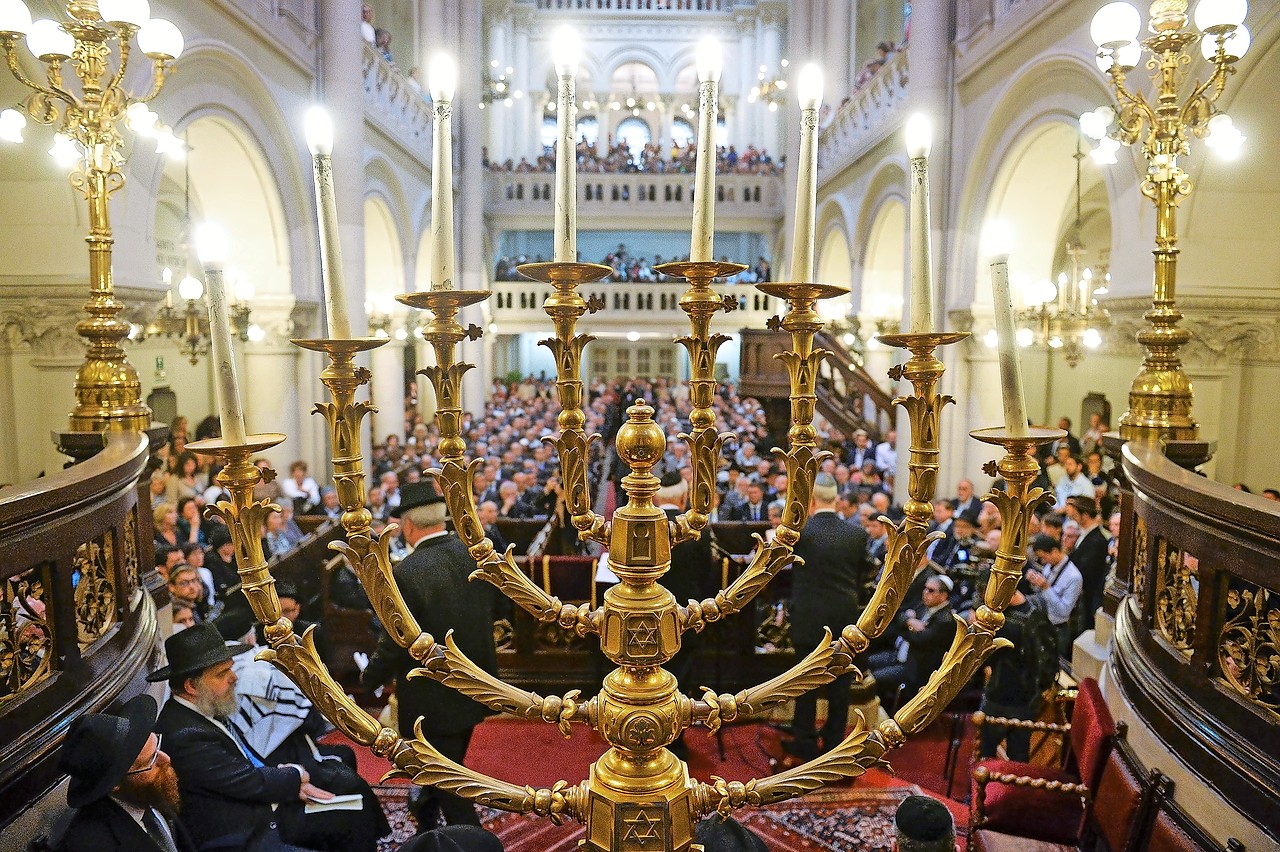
[{"x1": 113, "y1": 40, "x2": 320, "y2": 301}]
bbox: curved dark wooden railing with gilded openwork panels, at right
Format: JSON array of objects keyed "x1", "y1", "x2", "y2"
[{"x1": 1112, "y1": 443, "x2": 1280, "y2": 837}]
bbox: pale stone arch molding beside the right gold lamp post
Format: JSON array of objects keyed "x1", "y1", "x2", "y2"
[{"x1": 952, "y1": 51, "x2": 1152, "y2": 310}]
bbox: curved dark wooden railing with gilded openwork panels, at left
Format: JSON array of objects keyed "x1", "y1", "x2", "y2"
[{"x1": 0, "y1": 432, "x2": 160, "y2": 825}]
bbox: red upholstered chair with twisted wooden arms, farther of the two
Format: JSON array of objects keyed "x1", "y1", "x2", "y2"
[{"x1": 970, "y1": 678, "x2": 1116, "y2": 843}]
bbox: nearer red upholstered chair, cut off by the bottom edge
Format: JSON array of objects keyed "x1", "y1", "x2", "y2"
[{"x1": 969, "y1": 725, "x2": 1158, "y2": 852}]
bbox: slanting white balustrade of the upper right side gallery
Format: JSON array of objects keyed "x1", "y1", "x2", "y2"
[{"x1": 818, "y1": 50, "x2": 910, "y2": 178}]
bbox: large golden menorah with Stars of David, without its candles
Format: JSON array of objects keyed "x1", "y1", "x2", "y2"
[{"x1": 188, "y1": 262, "x2": 1062, "y2": 852}]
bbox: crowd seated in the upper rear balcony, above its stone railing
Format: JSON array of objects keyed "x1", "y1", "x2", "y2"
[{"x1": 483, "y1": 134, "x2": 785, "y2": 175}]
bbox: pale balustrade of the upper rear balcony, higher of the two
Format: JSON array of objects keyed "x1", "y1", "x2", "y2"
[{"x1": 485, "y1": 171, "x2": 783, "y2": 229}]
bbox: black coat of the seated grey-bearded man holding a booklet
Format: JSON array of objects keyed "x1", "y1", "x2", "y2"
[{"x1": 155, "y1": 698, "x2": 302, "y2": 849}]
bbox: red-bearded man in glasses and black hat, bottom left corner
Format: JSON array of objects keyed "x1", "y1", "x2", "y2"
[{"x1": 56, "y1": 695, "x2": 196, "y2": 852}]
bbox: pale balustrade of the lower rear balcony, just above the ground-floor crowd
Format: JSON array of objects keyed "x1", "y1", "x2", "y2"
[{"x1": 489, "y1": 280, "x2": 785, "y2": 333}]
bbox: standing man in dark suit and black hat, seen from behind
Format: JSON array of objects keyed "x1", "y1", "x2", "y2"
[{"x1": 364, "y1": 482, "x2": 498, "y2": 829}]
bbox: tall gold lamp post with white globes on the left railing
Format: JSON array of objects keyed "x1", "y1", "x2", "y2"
[{"x1": 0, "y1": 0, "x2": 183, "y2": 432}]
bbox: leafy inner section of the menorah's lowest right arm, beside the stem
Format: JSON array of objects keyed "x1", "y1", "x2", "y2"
[{"x1": 694, "y1": 714, "x2": 892, "y2": 819}]
